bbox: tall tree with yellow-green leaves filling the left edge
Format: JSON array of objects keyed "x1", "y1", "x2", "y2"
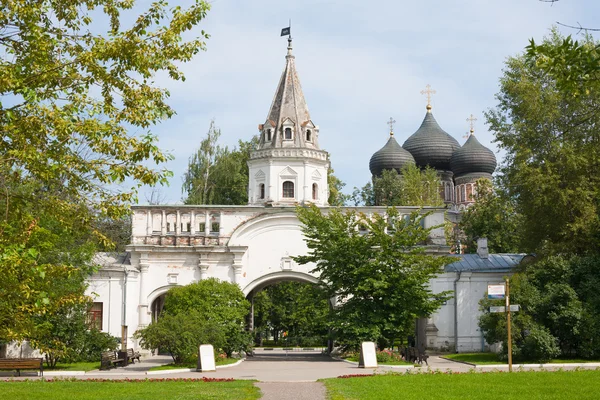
[{"x1": 0, "y1": 0, "x2": 209, "y2": 340}]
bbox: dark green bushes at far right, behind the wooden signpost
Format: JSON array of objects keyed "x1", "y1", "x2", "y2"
[{"x1": 479, "y1": 256, "x2": 600, "y2": 361}]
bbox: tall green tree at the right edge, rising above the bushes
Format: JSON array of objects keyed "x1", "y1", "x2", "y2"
[{"x1": 486, "y1": 30, "x2": 600, "y2": 254}]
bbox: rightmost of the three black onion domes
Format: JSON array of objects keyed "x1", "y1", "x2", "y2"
[{"x1": 450, "y1": 135, "x2": 496, "y2": 176}]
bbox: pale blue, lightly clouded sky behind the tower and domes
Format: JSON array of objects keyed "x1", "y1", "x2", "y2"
[{"x1": 134, "y1": 0, "x2": 600, "y2": 204}]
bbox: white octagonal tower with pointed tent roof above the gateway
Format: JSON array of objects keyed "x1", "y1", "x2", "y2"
[{"x1": 248, "y1": 37, "x2": 329, "y2": 206}]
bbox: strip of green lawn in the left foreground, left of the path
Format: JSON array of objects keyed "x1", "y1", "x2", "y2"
[{"x1": 0, "y1": 381, "x2": 260, "y2": 400}]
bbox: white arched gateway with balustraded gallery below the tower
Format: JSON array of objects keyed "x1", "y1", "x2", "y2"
[{"x1": 89, "y1": 205, "x2": 447, "y2": 344}]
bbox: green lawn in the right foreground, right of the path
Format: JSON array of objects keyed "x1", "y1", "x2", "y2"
[{"x1": 322, "y1": 371, "x2": 600, "y2": 400}]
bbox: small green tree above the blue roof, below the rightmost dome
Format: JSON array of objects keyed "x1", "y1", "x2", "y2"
[{"x1": 459, "y1": 179, "x2": 522, "y2": 253}]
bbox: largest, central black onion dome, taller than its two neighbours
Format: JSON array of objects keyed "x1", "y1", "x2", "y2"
[{"x1": 402, "y1": 111, "x2": 460, "y2": 171}]
